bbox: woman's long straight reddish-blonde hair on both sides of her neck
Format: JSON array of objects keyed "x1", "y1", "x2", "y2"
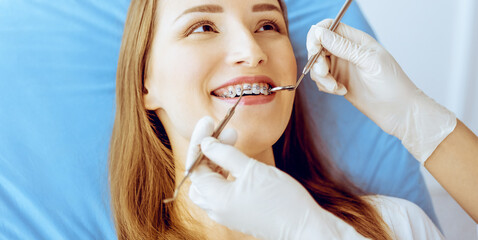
[{"x1": 109, "y1": 0, "x2": 390, "y2": 239}]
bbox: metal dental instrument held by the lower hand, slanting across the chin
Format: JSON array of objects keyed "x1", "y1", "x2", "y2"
[{"x1": 163, "y1": 90, "x2": 244, "y2": 203}]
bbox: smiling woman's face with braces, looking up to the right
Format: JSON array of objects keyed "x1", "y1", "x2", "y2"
[{"x1": 144, "y1": 0, "x2": 297, "y2": 160}]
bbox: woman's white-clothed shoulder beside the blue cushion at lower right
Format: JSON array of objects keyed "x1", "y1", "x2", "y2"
[{"x1": 364, "y1": 195, "x2": 444, "y2": 239}]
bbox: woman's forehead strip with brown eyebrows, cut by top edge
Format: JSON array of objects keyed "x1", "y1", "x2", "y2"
[{"x1": 159, "y1": 0, "x2": 280, "y2": 17}]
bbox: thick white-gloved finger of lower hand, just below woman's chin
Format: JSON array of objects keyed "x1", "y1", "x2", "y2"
[{"x1": 201, "y1": 137, "x2": 253, "y2": 178}]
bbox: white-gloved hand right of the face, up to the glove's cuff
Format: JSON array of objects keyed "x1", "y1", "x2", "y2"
[{"x1": 307, "y1": 19, "x2": 456, "y2": 163}]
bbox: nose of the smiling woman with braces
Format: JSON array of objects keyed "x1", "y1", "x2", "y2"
[{"x1": 226, "y1": 28, "x2": 267, "y2": 67}]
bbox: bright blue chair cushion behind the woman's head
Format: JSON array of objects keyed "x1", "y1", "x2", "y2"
[{"x1": 0, "y1": 0, "x2": 435, "y2": 239}]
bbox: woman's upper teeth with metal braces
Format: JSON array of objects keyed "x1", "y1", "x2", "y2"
[{"x1": 214, "y1": 83, "x2": 270, "y2": 98}]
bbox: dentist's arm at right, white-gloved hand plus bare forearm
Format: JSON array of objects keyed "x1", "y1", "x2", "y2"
[{"x1": 307, "y1": 20, "x2": 478, "y2": 222}]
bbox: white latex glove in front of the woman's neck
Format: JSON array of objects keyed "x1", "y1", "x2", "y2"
[{"x1": 186, "y1": 117, "x2": 365, "y2": 240}]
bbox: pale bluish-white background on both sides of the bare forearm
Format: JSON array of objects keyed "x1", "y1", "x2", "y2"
[{"x1": 358, "y1": 0, "x2": 478, "y2": 239}]
